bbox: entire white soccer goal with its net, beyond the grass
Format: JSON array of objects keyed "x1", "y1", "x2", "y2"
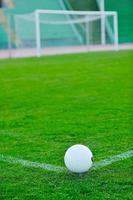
[{"x1": 15, "y1": 10, "x2": 118, "y2": 56}]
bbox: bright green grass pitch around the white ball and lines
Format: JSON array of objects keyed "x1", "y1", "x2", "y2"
[{"x1": 0, "y1": 51, "x2": 133, "y2": 200}]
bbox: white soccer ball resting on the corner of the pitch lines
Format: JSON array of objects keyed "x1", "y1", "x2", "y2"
[{"x1": 64, "y1": 144, "x2": 93, "y2": 173}]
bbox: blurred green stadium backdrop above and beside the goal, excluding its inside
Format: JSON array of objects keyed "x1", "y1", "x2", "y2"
[{"x1": 0, "y1": 0, "x2": 133, "y2": 49}]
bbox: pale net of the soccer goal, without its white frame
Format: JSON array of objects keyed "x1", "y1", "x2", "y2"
[{"x1": 14, "y1": 13, "x2": 114, "y2": 48}]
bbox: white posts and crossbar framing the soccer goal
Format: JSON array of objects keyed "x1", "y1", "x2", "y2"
[{"x1": 35, "y1": 10, "x2": 118, "y2": 56}]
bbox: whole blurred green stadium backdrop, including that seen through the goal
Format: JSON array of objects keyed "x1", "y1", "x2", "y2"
[{"x1": 0, "y1": 0, "x2": 133, "y2": 56}]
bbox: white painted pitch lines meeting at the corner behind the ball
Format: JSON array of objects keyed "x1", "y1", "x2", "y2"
[{"x1": 0, "y1": 150, "x2": 133, "y2": 172}]
